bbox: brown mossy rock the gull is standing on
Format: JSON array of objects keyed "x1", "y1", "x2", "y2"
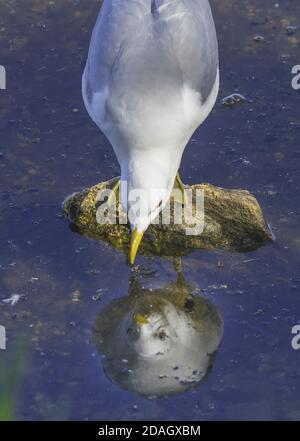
[{"x1": 63, "y1": 178, "x2": 273, "y2": 256}]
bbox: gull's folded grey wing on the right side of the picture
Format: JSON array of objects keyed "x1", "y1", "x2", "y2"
[{"x1": 152, "y1": 0, "x2": 219, "y2": 102}]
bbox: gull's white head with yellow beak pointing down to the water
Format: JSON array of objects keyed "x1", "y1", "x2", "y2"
[{"x1": 121, "y1": 154, "x2": 177, "y2": 264}]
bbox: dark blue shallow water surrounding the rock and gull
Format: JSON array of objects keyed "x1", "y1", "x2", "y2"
[{"x1": 0, "y1": 0, "x2": 300, "y2": 420}]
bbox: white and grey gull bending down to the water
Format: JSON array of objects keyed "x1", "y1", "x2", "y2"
[{"x1": 82, "y1": 0, "x2": 219, "y2": 263}]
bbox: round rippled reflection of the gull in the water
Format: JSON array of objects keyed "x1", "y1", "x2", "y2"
[{"x1": 94, "y1": 277, "x2": 223, "y2": 396}]
